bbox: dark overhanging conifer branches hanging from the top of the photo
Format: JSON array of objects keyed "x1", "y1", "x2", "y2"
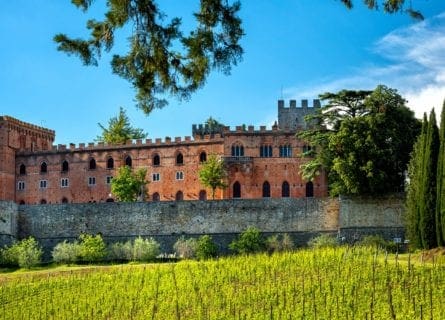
[{"x1": 54, "y1": 0, "x2": 423, "y2": 114}]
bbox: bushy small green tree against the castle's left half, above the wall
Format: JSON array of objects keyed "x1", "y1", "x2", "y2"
[{"x1": 111, "y1": 166, "x2": 148, "y2": 202}]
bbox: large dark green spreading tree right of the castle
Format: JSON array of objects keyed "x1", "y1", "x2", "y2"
[{"x1": 298, "y1": 86, "x2": 419, "y2": 195}]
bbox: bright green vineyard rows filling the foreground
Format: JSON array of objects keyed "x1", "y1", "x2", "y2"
[{"x1": 0, "y1": 248, "x2": 445, "y2": 320}]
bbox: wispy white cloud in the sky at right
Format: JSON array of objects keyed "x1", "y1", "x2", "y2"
[{"x1": 284, "y1": 12, "x2": 445, "y2": 117}]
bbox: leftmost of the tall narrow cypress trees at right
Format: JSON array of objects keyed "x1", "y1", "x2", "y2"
[{"x1": 405, "y1": 114, "x2": 428, "y2": 248}]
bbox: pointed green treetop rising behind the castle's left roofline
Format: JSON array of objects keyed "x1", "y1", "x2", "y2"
[{"x1": 97, "y1": 107, "x2": 147, "y2": 144}]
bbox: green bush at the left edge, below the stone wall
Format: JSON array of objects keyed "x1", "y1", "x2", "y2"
[{"x1": 0, "y1": 237, "x2": 43, "y2": 269}]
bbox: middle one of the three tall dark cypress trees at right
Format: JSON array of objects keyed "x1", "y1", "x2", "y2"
[{"x1": 419, "y1": 109, "x2": 439, "y2": 249}]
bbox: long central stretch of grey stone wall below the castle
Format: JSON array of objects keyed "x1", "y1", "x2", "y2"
[{"x1": 19, "y1": 198, "x2": 338, "y2": 252}]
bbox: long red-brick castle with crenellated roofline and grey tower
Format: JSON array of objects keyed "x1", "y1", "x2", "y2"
[{"x1": 0, "y1": 100, "x2": 327, "y2": 204}]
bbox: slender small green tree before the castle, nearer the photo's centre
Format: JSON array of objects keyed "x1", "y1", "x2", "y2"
[{"x1": 199, "y1": 154, "x2": 227, "y2": 199}]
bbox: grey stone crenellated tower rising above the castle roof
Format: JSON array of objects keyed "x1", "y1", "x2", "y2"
[{"x1": 278, "y1": 99, "x2": 321, "y2": 131}]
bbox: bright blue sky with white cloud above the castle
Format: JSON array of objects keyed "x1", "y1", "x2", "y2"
[{"x1": 0, "y1": 0, "x2": 445, "y2": 144}]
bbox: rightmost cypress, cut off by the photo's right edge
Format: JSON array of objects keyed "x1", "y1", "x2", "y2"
[{"x1": 436, "y1": 101, "x2": 445, "y2": 246}]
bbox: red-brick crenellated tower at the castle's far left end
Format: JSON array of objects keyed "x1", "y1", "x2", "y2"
[{"x1": 0, "y1": 116, "x2": 55, "y2": 201}]
